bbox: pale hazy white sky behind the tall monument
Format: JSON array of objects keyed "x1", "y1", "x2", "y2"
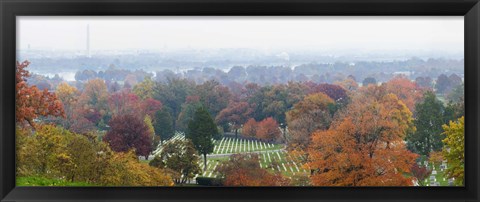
[{"x1": 17, "y1": 16, "x2": 464, "y2": 52}]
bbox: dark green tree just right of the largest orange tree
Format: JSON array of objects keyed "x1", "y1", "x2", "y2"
[{"x1": 407, "y1": 91, "x2": 450, "y2": 156}]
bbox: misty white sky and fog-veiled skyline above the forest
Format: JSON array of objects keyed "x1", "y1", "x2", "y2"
[{"x1": 17, "y1": 16, "x2": 464, "y2": 83}]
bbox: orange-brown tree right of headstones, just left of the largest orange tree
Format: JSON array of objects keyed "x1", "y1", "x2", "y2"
[{"x1": 287, "y1": 93, "x2": 335, "y2": 149}]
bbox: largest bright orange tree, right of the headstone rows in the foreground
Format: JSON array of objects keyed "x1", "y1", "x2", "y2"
[{"x1": 307, "y1": 85, "x2": 417, "y2": 186}]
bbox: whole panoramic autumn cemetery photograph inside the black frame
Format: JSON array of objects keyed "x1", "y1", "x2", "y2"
[{"x1": 12, "y1": 16, "x2": 464, "y2": 189}]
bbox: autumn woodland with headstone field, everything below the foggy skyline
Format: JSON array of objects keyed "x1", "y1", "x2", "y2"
[{"x1": 16, "y1": 54, "x2": 465, "y2": 186}]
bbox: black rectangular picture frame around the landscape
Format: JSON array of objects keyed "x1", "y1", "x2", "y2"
[{"x1": 0, "y1": 0, "x2": 480, "y2": 202}]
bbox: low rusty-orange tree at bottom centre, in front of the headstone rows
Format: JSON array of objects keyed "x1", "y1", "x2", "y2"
[{"x1": 216, "y1": 154, "x2": 290, "y2": 186}]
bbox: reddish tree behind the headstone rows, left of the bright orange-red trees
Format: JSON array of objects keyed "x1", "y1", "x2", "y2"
[{"x1": 215, "y1": 102, "x2": 253, "y2": 138}]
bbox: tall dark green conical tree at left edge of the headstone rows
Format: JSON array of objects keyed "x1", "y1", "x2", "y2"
[{"x1": 186, "y1": 107, "x2": 218, "y2": 170}]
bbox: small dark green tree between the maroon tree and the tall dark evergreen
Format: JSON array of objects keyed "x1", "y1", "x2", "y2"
[{"x1": 153, "y1": 109, "x2": 174, "y2": 140}]
